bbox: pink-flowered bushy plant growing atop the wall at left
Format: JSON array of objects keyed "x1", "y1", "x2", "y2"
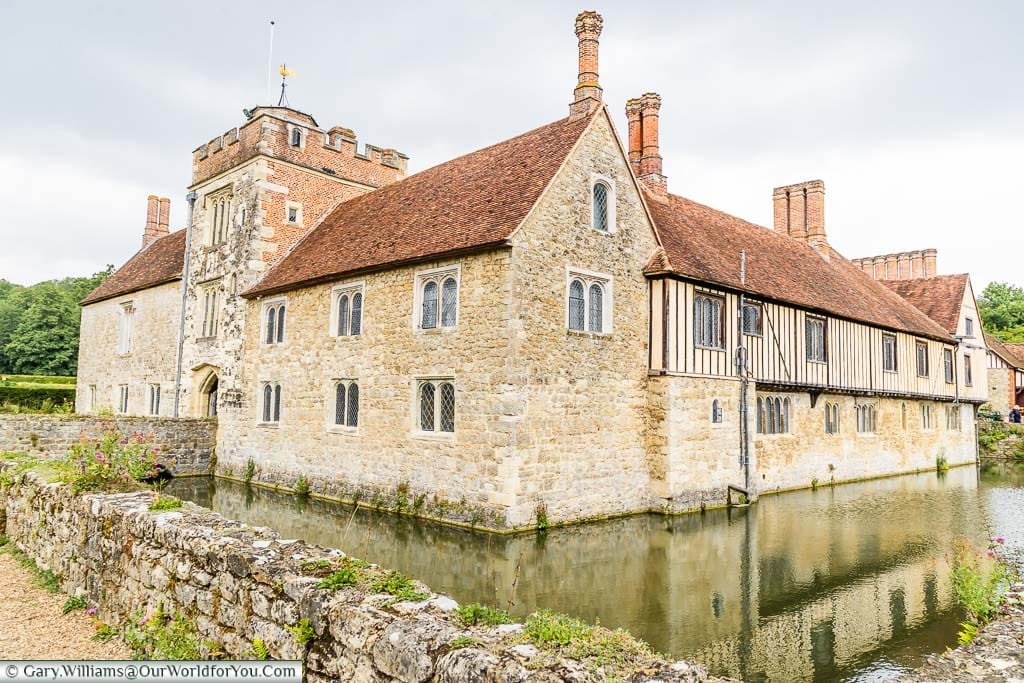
[{"x1": 65, "y1": 425, "x2": 157, "y2": 493}]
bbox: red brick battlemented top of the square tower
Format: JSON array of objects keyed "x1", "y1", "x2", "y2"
[{"x1": 193, "y1": 106, "x2": 409, "y2": 187}]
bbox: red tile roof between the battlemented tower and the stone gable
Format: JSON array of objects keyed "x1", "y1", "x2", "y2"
[{"x1": 245, "y1": 110, "x2": 600, "y2": 297}]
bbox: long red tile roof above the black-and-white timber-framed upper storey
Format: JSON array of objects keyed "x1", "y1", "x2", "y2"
[{"x1": 644, "y1": 190, "x2": 949, "y2": 339}]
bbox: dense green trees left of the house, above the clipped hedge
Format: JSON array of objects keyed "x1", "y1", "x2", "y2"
[{"x1": 0, "y1": 266, "x2": 114, "y2": 375}]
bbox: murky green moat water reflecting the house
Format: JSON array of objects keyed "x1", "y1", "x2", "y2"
[{"x1": 168, "y1": 465, "x2": 1024, "y2": 681}]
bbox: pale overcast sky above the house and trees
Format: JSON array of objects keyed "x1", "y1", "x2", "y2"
[{"x1": 0, "y1": 0, "x2": 1024, "y2": 291}]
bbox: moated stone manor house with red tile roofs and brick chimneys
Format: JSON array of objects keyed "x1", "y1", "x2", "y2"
[{"x1": 77, "y1": 12, "x2": 988, "y2": 529}]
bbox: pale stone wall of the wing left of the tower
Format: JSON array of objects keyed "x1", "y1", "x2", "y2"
[{"x1": 75, "y1": 281, "x2": 181, "y2": 417}]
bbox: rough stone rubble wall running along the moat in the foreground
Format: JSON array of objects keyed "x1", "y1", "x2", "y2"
[{"x1": 0, "y1": 471, "x2": 712, "y2": 683}]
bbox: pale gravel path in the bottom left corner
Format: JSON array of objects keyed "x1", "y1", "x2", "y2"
[{"x1": 0, "y1": 554, "x2": 131, "y2": 659}]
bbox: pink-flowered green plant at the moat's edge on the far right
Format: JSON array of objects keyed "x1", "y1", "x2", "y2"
[{"x1": 951, "y1": 539, "x2": 1014, "y2": 642}]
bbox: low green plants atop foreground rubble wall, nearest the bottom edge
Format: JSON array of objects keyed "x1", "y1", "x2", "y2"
[{"x1": 523, "y1": 609, "x2": 654, "y2": 667}]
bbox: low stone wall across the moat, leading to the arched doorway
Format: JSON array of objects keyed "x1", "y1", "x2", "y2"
[{"x1": 0, "y1": 415, "x2": 217, "y2": 475}]
